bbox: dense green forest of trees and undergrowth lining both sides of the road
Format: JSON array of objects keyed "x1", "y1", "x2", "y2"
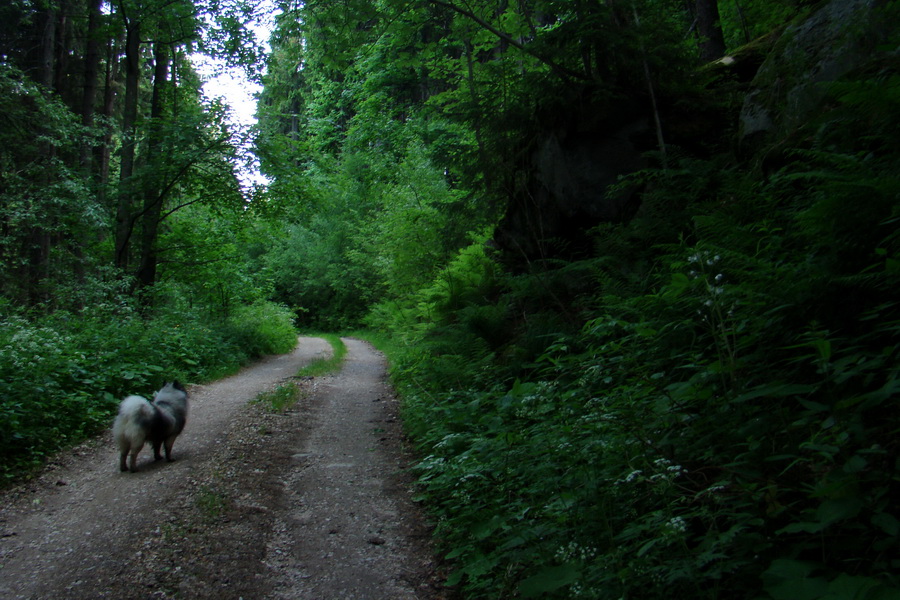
[{"x1": 0, "y1": 0, "x2": 900, "y2": 600}]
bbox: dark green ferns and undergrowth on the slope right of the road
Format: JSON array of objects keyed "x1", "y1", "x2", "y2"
[{"x1": 370, "y1": 69, "x2": 900, "y2": 600}]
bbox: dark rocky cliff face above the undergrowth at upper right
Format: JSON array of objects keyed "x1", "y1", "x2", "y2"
[{"x1": 494, "y1": 0, "x2": 900, "y2": 264}]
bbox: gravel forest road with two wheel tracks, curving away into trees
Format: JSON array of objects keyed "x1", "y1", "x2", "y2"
[{"x1": 0, "y1": 338, "x2": 445, "y2": 600}]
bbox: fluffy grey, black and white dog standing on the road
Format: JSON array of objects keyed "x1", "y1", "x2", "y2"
[{"x1": 113, "y1": 381, "x2": 187, "y2": 473}]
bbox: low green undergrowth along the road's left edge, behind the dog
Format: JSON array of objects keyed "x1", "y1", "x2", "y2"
[{"x1": 0, "y1": 303, "x2": 297, "y2": 484}]
